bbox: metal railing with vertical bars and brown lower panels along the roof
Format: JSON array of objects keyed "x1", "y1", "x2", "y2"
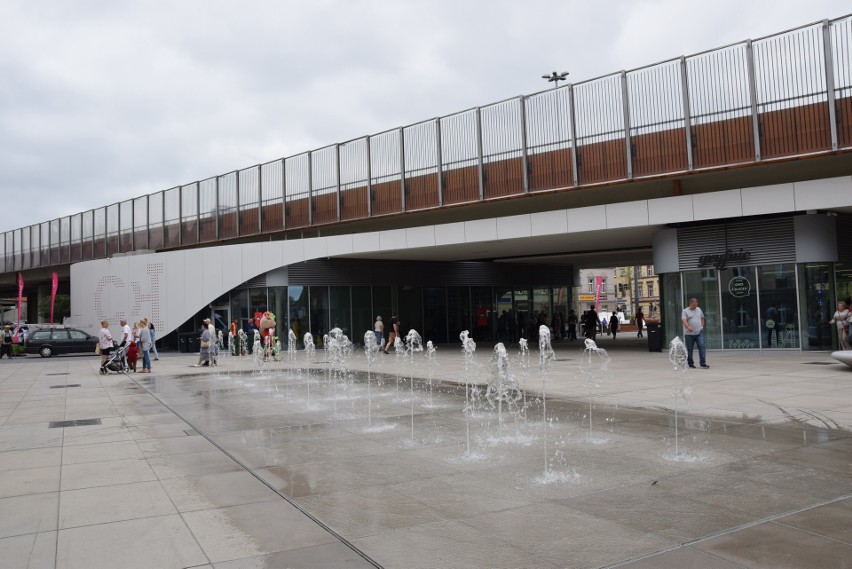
[{"x1": 0, "y1": 16, "x2": 852, "y2": 272}]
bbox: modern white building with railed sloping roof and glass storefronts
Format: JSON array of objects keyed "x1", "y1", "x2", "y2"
[{"x1": 0, "y1": 16, "x2": 852, "y2": 350}]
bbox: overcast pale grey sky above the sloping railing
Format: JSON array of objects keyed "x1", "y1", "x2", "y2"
[{"x1": 0, "y1": 0, "x2": 852, "y2": 231}]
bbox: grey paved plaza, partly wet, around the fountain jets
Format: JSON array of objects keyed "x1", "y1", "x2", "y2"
[{"x1": 0, "y1": 337, "x2": 852, "y2": 569}]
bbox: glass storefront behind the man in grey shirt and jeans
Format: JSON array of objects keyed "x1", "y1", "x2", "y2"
[{"x1": 660, "y1": 263, "x2": 852, "y2": 350}]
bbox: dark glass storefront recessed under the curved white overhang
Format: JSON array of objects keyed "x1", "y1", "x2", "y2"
[{"x1": 188, "y1": 285, "x2": 570, "y2": 349}]
